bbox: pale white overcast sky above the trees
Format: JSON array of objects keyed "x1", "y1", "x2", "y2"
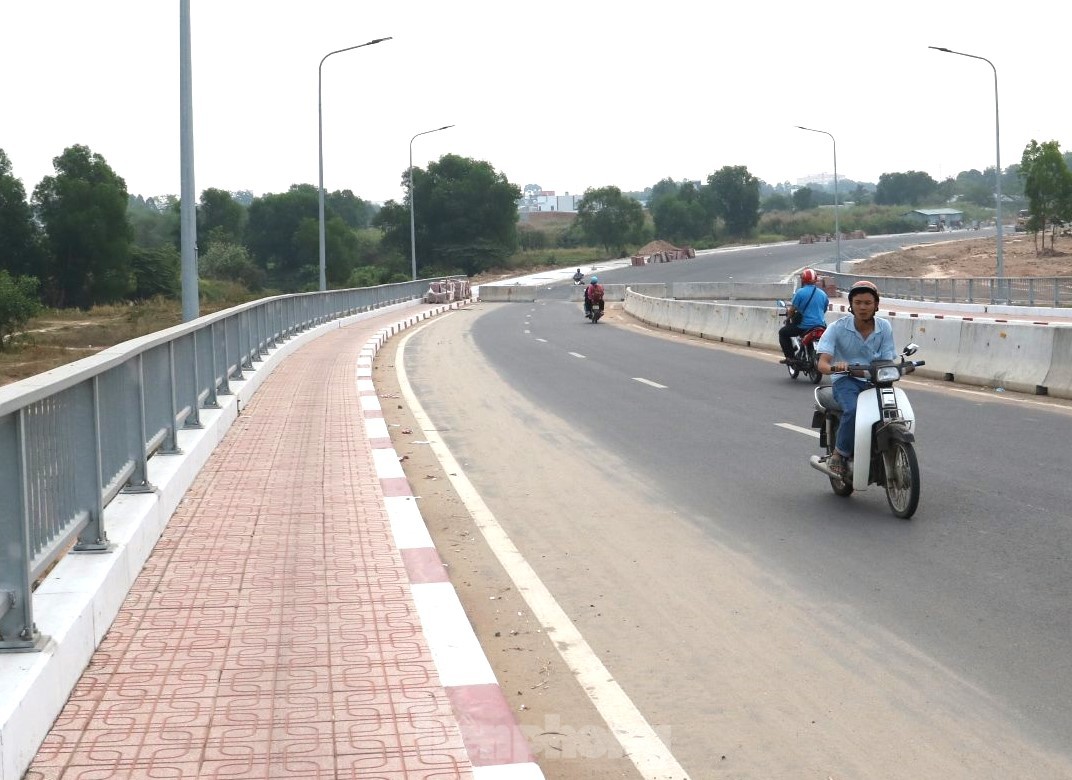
[{"x1": 0, "y1": 0, "x2": 1072, "y2": 203}]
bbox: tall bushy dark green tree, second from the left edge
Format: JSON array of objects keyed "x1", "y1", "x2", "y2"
[{"x1": 33, "y1": 145, "x2": 133, "y2": 309}]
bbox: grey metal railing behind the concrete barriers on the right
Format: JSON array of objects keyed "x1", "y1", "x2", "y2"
[{"x1": 822, "y1": 271, "x2": 1072, "y2": 306}]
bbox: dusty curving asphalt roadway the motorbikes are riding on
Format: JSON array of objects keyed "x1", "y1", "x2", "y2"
[{"x1": 411, "y1": 295, "x2": 1072, "y2": 777}]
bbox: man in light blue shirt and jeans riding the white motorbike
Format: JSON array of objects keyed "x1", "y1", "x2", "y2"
[{"x1": 816, "y1": 281, "x2": 896, "y2": 476}]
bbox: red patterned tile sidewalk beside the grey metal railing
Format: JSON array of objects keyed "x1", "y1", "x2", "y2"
[{"x1": 26, "y1": 315, "x2": 472, "y2": 780}]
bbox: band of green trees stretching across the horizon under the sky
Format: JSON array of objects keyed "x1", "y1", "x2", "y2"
[{"x1": 0, "y1": 140, "x2": 1072, "y2": 346}]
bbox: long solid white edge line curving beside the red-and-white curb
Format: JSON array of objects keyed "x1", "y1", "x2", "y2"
[{"x1": 394, "y1": 323, "x2": 688, "y2": 778}]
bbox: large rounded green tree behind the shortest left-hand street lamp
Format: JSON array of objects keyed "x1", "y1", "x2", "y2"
[{"x1": 373, "y1": 154, "x2": 521, "y2": 276}]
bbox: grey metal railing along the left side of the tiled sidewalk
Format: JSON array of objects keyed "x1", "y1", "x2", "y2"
[{"x1": 0, "y1": 280, "x2": 439, "y2": 651}]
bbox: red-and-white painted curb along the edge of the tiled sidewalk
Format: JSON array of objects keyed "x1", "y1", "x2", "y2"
[{"x1": 357, "y1": 303, "x2": 544, "y2": 780}]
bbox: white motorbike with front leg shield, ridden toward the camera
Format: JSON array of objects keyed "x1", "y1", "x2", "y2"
[{"x1": 810, "y1": 344, "x2": 925, "y2": 520}]
